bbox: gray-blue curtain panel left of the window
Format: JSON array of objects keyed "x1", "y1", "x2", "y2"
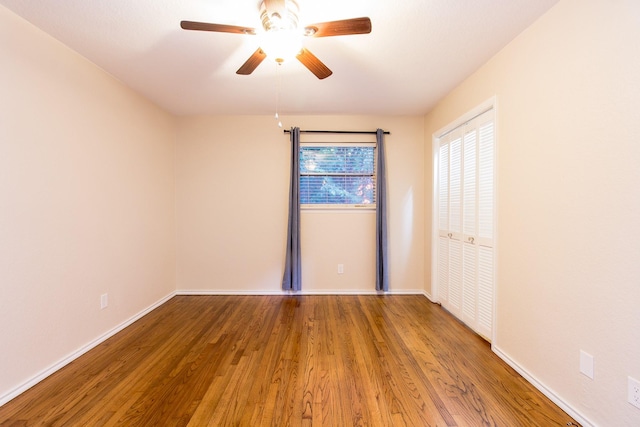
[{"x1": 282, "y1": 127, "x2": 302, "y2": 291}]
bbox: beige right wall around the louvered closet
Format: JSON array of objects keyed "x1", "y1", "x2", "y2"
[{"x1": 425, "y1": 0, "x2": 640, "y2": 426}]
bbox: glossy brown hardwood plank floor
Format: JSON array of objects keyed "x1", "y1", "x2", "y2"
[{"x1": 0, "y1": 295, "x2": 575, "y2": 427}]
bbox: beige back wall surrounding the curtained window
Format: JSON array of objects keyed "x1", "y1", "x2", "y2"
[{"x1": 176, "y1": 116, "x2": 424, "y2": 293}]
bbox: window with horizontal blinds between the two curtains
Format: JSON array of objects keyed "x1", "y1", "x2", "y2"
[{"x1": 300, "y1": 143, "x2": 376, "y2": 208}]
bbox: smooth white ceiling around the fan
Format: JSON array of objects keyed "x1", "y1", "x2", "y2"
[{"x1": 0, "y1": 0, "x2": 558, "y2": 115}]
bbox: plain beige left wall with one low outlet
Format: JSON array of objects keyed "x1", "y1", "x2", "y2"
[{"x1": 0, "y1": 6, "x2": 175, "y2": 400}]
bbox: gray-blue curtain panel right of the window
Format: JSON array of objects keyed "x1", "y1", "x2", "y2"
[{"x1": 376, "y1": 129, "x2": 389, "y2": 291}]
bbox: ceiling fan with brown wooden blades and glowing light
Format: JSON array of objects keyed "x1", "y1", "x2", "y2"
[{"x1": 180, "y1": 0, "x2": 371, "y2": 79}]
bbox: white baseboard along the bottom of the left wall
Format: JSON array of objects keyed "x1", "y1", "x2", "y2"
[{"x1": 0, "y1": 292, "x2": 175, "y2": 406}]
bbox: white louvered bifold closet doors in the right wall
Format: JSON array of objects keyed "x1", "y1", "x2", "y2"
[{"x1": 437, "y1": 111, "x2": 495, "y2": 339}]
